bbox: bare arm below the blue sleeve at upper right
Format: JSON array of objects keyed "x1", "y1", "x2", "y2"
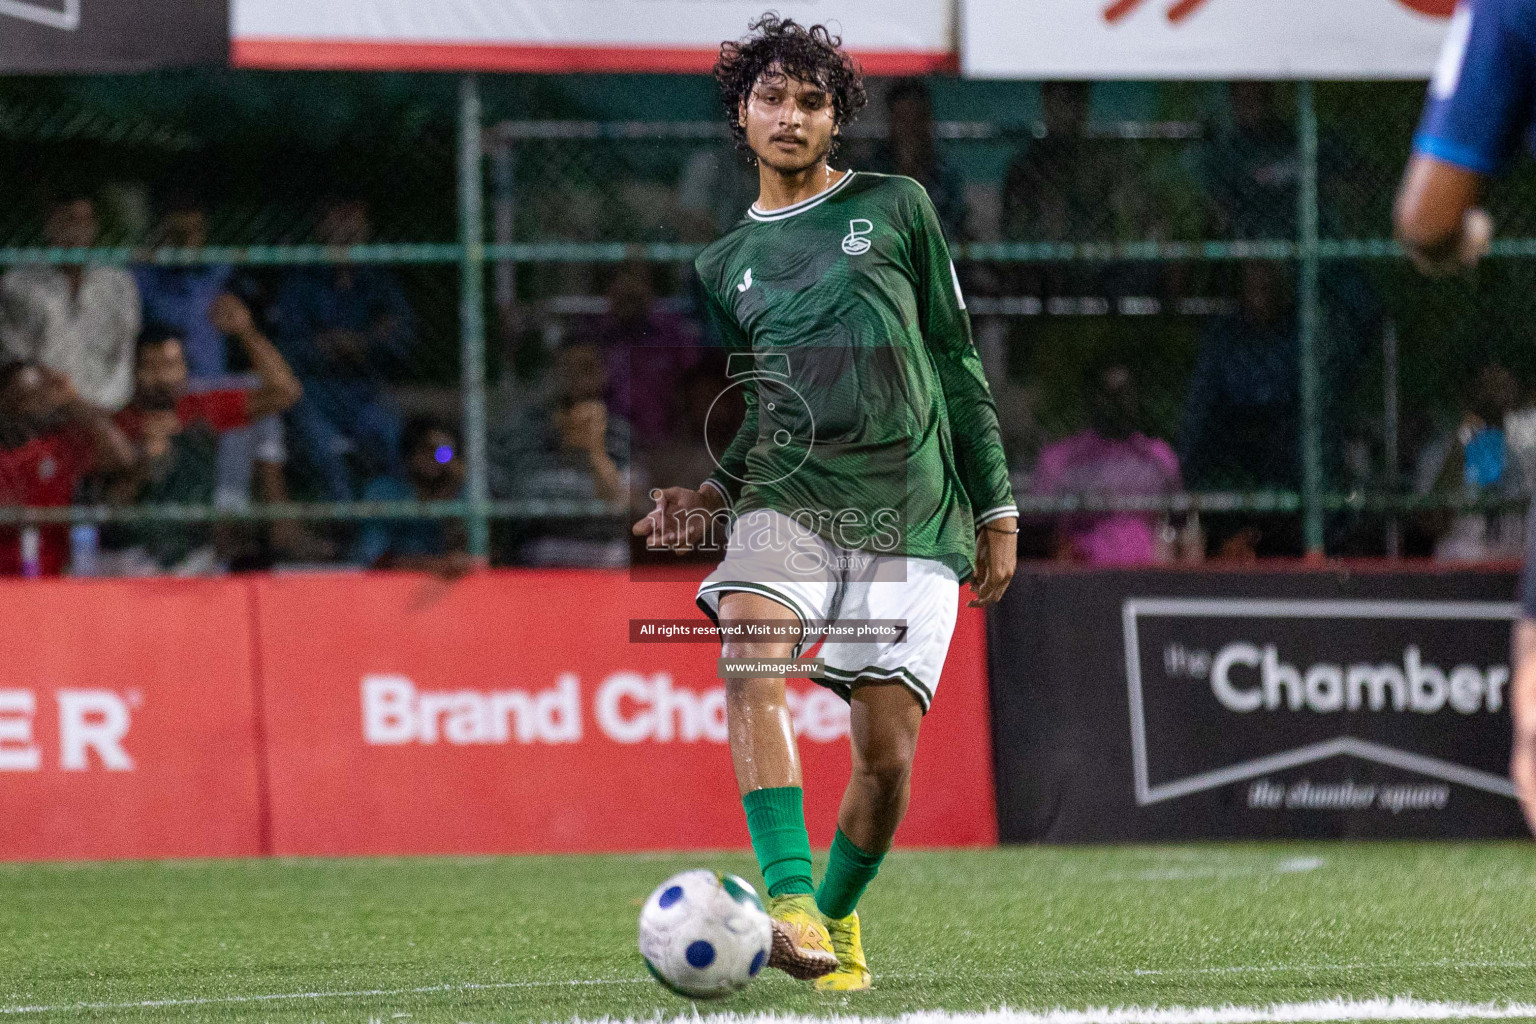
[{"x1": 1393, "y1": 154, "x2": 1493, "y2": 275}]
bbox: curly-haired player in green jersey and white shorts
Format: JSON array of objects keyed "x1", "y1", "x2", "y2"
[{"x1": 634, "y1": 15, "x2": 1018, "y2": 992}]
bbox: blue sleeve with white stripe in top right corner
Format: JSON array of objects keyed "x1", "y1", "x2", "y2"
[{"x1": 1413, "y1": 0, "x2": 1531, "y2": 175}]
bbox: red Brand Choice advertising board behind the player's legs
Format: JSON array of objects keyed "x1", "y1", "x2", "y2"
[{"x1": 253, "y1": 570, "x2": 997, "y2": 855}]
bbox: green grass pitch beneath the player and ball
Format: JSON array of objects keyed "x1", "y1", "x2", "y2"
[{"x1": 0, "y1": 843, "x2": 1536, "y2": 1024}]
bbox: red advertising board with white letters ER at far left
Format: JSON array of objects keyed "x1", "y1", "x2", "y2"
[{"x1": 0, "y1": 580, "x2": 261, "y2": 860}]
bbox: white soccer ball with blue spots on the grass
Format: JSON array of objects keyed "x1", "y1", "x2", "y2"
[{"x1": 641, "y1": 869, "x2": 773, "y2": 999}]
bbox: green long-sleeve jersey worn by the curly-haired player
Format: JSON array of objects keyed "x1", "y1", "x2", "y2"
[{"x1": 694, "y1": 172, "x2": 1017, "y2": 580}]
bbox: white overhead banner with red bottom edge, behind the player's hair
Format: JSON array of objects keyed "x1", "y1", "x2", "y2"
[{"x1": 231, "y1": 0, "x2": 955, "y2": 74}]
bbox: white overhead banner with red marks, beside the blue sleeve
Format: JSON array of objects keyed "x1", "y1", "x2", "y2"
[{"x1": 960, "y1": 0, "x2": 1455, "y2": 78}]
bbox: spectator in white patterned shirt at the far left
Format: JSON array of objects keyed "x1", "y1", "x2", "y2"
[{"x1": 0, "y1": 192, "x2": 140, "y2": 411}]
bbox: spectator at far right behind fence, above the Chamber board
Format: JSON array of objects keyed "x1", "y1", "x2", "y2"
[{"x1": 1413, "y1": 364, "x2": 1528, "y2": 562}]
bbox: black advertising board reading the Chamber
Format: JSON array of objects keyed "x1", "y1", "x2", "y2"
[{"x1": 989, "y1": 570, "x2": 1524, "y2": 843}]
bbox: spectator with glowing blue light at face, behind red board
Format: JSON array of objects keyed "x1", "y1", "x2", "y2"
[{"x1": 352, "y1": 416, "x2": 482, "y2": 579}]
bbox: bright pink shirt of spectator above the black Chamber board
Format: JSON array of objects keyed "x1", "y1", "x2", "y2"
[{"x1": 1029, "y1": 430, "x2": 1183, "y2": 565}]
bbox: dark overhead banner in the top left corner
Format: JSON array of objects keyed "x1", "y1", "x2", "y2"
[{"x1": 0, "y1": 0, "x2": 229, "y2": 74}]
